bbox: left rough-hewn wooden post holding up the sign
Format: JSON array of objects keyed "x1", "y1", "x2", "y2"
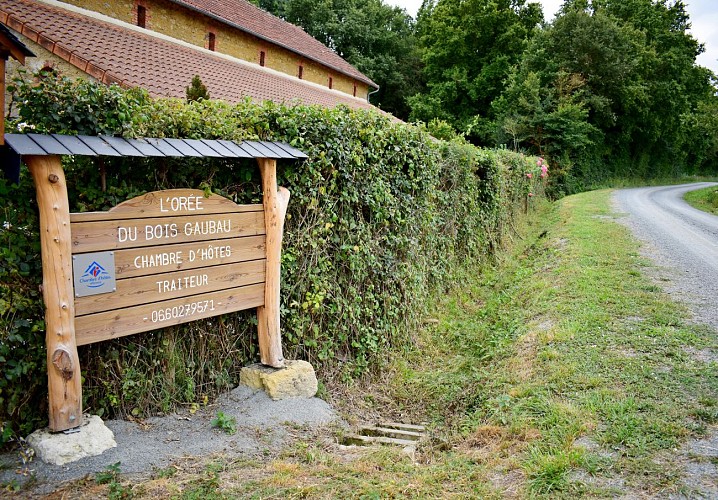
[{"x1": 24, "y1": 156, "x2": 82, "y2": 432}]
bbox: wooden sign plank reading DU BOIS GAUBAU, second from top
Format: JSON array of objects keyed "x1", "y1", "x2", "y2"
[{"x1": 72, "y1": 212, "x2": 265, "y2": 253}]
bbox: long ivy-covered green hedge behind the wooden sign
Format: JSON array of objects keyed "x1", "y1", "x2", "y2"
[{"x1": 0, "y1": 75, "x2": 543, "y2": 444}]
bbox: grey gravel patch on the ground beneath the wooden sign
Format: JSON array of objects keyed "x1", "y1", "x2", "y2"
[{"x1": 0, "y1": 386, "x2": 340, "y2": 497}]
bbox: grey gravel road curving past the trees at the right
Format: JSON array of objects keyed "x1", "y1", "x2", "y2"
[{"x1": 614, "y1": 182, "x2": 718, "y2": 330}]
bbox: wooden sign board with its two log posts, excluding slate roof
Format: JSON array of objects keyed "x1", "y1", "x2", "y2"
[{"x1": 24, "y1": 155, "x2": 289, "y2": 432}]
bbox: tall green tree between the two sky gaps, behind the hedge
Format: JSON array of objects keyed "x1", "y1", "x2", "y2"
[{"x1": 409, "y1": 0, "x2": 543, "y2": 144}]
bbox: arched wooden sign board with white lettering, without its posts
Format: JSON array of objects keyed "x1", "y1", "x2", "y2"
[{"x1": 70, "y1": 189, "x2": 266, "y2": 345}]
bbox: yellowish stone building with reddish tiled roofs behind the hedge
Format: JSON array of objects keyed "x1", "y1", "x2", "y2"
[{"x1": 0, "y1": 0, "x2": 377, "y2": 109}]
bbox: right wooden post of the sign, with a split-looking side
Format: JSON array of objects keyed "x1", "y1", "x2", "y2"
[{"x1": 257, "y1": 158, "x2": 289, "y2": 368}]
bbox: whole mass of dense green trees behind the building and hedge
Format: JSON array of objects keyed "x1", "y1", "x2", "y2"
[{"x1": 259, "y1": 0, "x2": 718, "y2": 186}]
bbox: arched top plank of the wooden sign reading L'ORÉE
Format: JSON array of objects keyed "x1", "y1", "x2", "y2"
[{"x1": 70, "y1": 189, "x2": 262, "y2": 222}]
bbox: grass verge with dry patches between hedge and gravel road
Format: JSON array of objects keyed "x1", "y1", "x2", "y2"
[{"x1": 52, "y1": 191, "x2": 718, "y2": 498}]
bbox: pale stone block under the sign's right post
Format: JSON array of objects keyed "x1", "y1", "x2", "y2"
[{"x1": 239, "y1": 360, "x2": 318, "y2": 401}]
